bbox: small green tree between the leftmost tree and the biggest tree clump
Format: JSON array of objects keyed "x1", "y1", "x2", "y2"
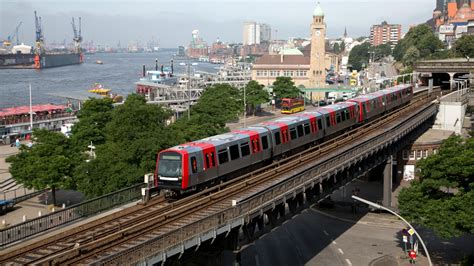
[{"x1": 71, "y1": 98, "x2": 113, "y2": 151}]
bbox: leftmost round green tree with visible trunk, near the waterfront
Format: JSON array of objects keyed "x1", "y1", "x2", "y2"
[{"x1": 7, "y1": 129, "x2": 80, "y2": 205}]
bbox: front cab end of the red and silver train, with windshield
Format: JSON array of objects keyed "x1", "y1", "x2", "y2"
[{"x1": 155, "y1": 149, "x2": 188, "y2": 192}]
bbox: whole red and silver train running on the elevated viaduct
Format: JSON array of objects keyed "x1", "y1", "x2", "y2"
[{"x1": 154, "y1": 85, "x2": 413, "y2": 193}]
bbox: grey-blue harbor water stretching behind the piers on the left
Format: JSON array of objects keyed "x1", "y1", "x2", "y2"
[{"x1": 0, "y1": 50, "x2": 219, "y2": 108}]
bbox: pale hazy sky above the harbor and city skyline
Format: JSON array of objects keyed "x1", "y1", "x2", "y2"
[{"x1": 0, "y1": 0, "x2": 436, "y2": 48}]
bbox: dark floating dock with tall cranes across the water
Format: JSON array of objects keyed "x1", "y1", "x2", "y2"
[{"x1": 0, "y1": 11, "x2": 84, "y2": 69}]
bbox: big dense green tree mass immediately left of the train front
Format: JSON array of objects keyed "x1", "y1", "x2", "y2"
[{"x1": 75, "y1": 94, "x2": 177, "y2": 197}]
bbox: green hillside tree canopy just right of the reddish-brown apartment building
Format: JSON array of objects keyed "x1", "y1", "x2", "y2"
[{"x1": 393, "y1": 24, "x2": 444, "y2": 63}]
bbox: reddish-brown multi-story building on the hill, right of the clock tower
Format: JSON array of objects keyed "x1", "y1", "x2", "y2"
[{"x1": 370, "y1": 21, "x2": 402, "y2": 48}]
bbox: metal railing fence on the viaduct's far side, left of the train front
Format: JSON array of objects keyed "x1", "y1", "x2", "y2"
[{"x1": 0, "y1": 184, "x2": 145, "y2": 248}]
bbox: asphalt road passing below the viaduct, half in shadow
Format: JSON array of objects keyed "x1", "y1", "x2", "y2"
[{"x1": 241, "y1": 208, "x2": 408, "y2": 266}]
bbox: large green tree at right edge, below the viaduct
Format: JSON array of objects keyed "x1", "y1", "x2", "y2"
[{"x1": 399, "y1": 136, "x2": 474, "y2": 238}]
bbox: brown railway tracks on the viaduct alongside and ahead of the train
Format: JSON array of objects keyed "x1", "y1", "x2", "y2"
[{"x1": 0, "y1": 88, "x2": 440, "y2": 265}]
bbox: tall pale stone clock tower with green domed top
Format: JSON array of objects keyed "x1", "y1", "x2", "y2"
[{"x1": 309, "y1": 2, "x2": 326, "y2": 88}]
